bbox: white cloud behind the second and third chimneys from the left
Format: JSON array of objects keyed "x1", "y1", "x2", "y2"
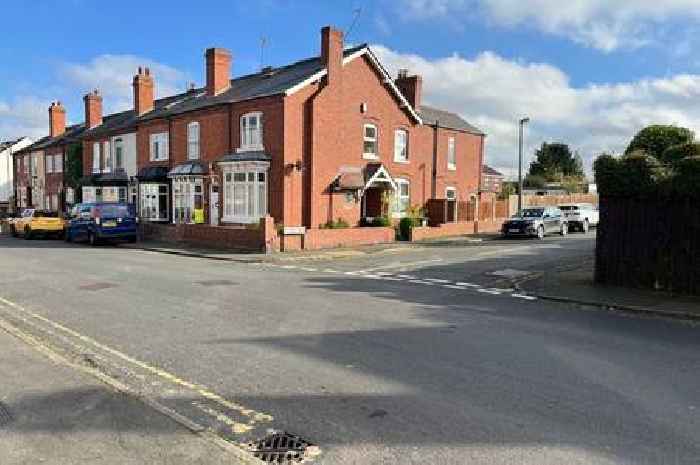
[{"x1": 59, "y1": 54, "x2": 187, "y2": 112}]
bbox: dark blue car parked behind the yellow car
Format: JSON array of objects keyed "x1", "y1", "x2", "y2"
[{"x1": 65, "y1": 203, "x2": 138, "y2": 245}]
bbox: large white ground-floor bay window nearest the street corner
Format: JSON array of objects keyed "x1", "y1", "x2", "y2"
[{"x1": 222, "y1": 162, "x2": 270, "y2": 224}]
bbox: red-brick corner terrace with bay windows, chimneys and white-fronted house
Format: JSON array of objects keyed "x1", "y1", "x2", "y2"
[{"x1": 13, "y1": 27, "x2": 485, "y2": 248}]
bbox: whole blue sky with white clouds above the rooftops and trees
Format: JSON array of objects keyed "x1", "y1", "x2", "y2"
[{"x1": 0, "y1": 0, "x2": 700, "y2": 175}]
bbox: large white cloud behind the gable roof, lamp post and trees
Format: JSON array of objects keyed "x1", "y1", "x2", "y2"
[{"x1": 372, "y1": 45, "x2": 700, "y2": 178}]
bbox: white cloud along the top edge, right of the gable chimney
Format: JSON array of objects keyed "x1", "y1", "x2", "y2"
[{"x1": 401, "y1": 0, "x2": 700, "y2": 52}]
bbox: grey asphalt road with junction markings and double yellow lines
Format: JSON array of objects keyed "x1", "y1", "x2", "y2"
[{"x1": 0, "y1": 235, "x2": 700, "y2": 465}]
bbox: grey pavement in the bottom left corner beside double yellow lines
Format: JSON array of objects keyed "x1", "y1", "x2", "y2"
[{"x1": 0, "y1": 320, "x2": 243, "y2": 465}]
